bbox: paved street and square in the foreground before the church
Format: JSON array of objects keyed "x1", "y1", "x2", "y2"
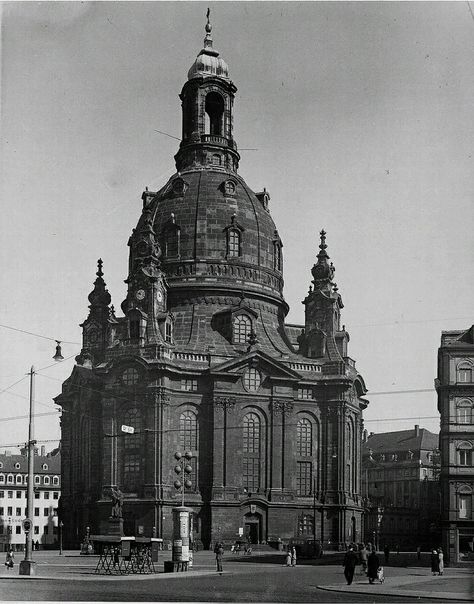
[{"x1": 0, "y1": 552, "x2": 472, "y2": 602}]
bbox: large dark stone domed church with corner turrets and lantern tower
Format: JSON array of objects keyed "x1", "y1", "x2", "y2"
[{"x1": 55, "y1": 16, "x2": 367, "y2": 548}]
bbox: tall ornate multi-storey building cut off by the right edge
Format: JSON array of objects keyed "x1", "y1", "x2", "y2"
[{"x1": 435, "y1": 325, "x2": 474, "y2": 564}]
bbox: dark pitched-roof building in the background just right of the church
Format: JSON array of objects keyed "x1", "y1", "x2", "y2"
[{"x1": 362, "y1": 425, "x2": 440, "y2": 550}]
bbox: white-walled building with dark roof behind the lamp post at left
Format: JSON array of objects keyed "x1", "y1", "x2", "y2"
[{"x1": 0, "y1": 447, "x2": 61, "y2": 551}]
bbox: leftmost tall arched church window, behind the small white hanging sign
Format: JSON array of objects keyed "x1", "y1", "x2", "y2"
[{"x1": 120, "y1": 407, "x2": 142, "y2": 492}]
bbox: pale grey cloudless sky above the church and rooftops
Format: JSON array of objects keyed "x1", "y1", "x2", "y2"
[{"x1": 0, "y1": 2, "x2": 474, "y2": 451}]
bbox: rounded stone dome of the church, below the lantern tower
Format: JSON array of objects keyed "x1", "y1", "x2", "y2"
[{"x1": 135, "y1": 168, "x2": 286, "y2": 304}]
